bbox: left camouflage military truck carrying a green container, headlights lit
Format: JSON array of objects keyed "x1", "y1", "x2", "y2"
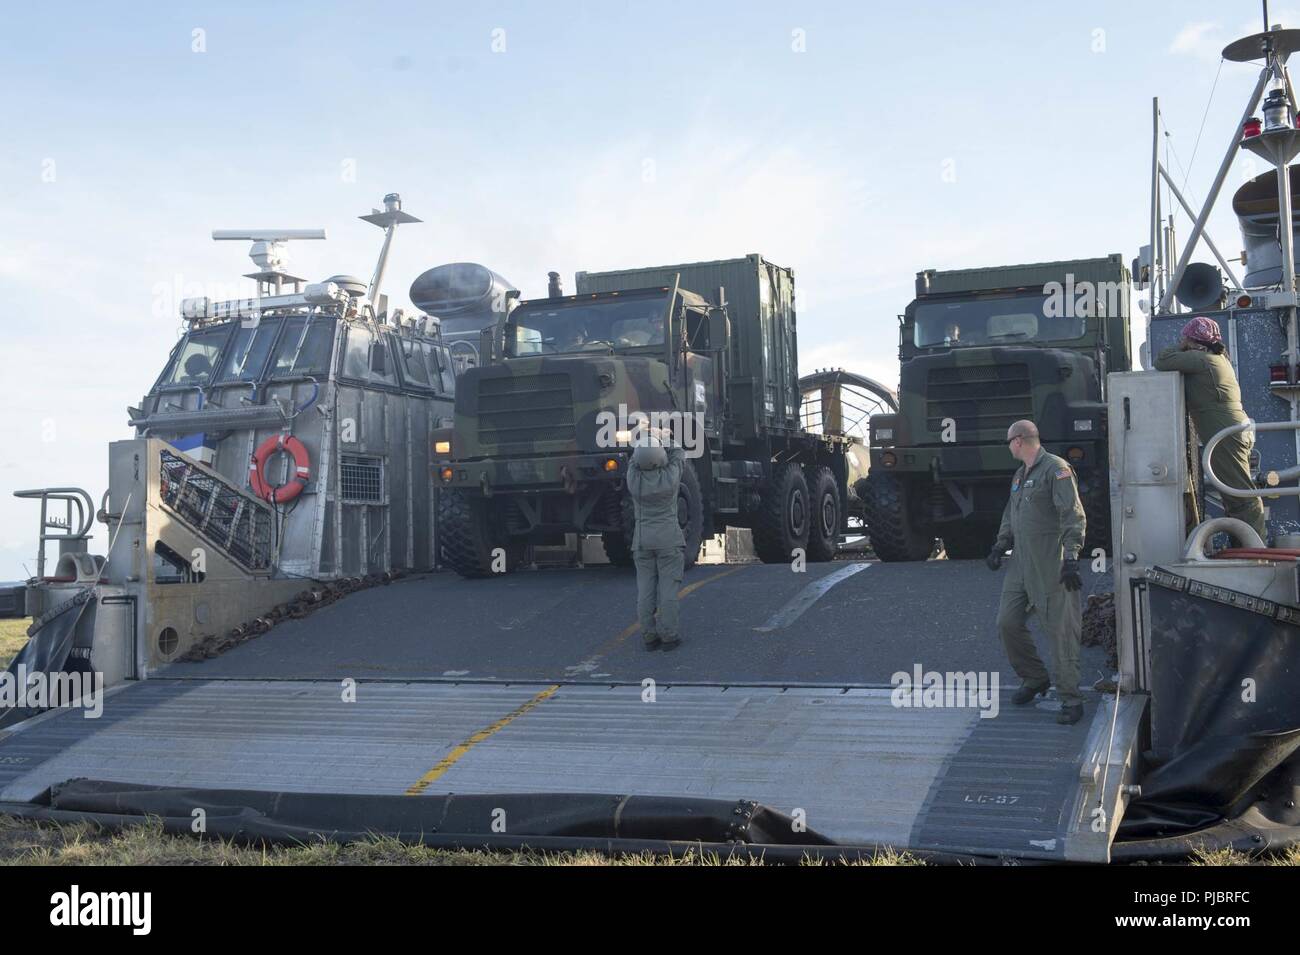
[{"x1": 434, "y1": 255, "x2": 848, "y2": 577}]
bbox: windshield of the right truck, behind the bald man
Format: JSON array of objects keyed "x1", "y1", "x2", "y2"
[{"x1": 913, "y1": 291, "x2": 1088, "y2": 348}]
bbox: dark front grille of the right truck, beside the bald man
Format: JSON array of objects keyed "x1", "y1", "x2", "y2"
[{"x1": 926, "y1": 365, "x2": 1034, "y2": 433}]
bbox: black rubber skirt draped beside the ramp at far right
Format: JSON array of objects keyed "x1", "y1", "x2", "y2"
[{"x1": 1121, "y1": 572, "x2": 1300, "y2": 839}]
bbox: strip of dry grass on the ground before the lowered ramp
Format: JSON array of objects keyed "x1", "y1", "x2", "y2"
[{"x1": 0, "y1": 816, "x2": 923, "y2": 867}]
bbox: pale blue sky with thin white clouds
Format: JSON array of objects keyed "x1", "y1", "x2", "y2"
[{"x1": 0, "y1": 0, "x2": 1300, "y2": 579}]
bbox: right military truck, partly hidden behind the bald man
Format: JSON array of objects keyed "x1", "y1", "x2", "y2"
[{"x1": 855, "y1": 255, "x2": 1132, "y2": 560}]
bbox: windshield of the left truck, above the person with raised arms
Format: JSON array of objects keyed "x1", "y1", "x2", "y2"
[{"x1": 510, "y1": 292, "x2": 668, "y2": 357}]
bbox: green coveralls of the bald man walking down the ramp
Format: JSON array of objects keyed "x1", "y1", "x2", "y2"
[{"x1": 996, "y1": 450, "x2": 1087, "y2": 704}]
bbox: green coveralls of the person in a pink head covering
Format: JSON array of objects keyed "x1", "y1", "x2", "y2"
[{"x1": 1156, "y1": 344, "x2": 1268, "y2": 539}]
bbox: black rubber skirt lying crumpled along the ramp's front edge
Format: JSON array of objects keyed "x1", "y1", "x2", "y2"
[{"x1": 17, "y1": 780, "x2": 831, "y2": 846}]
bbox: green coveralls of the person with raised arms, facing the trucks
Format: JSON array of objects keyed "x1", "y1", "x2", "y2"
[{"x1": 628, "y1": 448, "x2": 686, "y2": 643}]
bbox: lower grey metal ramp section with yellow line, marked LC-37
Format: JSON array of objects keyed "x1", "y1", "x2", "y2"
[{"x1": 0, "y1": 678, "x2": 1144, "y2": 861}]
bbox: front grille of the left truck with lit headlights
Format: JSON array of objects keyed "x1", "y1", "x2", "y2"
[{"x1": 478, "y1": 374, "x2": 577, "y2": 451}]
